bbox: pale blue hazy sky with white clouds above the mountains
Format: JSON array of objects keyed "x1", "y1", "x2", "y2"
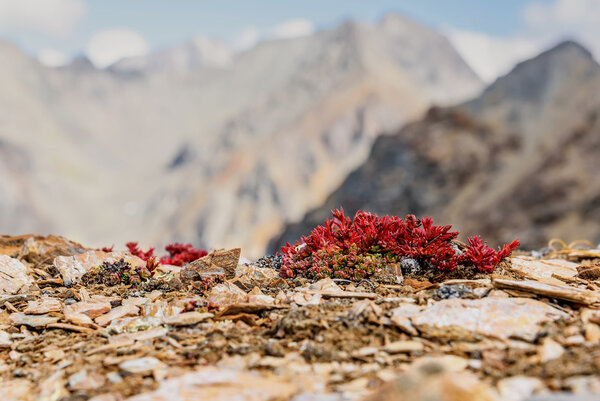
[{"x1": 0, "y1": 0, "x2": 600, "y2": 80}]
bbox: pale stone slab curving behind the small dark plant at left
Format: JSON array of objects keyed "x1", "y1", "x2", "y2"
[{"x1": 54, "y1": 251, "x2": 146, "y2": 286}]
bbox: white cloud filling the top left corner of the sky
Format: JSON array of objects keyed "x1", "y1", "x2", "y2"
[{"x1": 0, "y1": 0, "x2": 85, "y2": 37}]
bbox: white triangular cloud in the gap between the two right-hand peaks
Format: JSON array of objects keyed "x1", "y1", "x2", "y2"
[{"x1": 445, "y1": 28, "x2": 541, "y2": 82}]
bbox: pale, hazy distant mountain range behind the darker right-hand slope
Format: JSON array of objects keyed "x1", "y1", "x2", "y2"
[{"x1": 0, "y1": 15, "x2": 481, "y2": 255}]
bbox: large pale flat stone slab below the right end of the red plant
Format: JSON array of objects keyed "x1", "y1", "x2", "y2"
[{"x1": 410, "y1": 298, "x2": 568, "y2": 341}]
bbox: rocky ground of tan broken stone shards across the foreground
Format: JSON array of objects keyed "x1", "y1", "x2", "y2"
[{"x1": 0, "y1": 236, "x2": 600, "y2": 401}]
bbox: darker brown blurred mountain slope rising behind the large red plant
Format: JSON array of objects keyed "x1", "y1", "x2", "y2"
[{"x1": 271, "y1": 42, "x2": 600, "y2": 248}]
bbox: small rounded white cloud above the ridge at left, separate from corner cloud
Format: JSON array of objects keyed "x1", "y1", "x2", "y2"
[{"x1": 85, "y1": 28, "x2": 148, "y2": 68}]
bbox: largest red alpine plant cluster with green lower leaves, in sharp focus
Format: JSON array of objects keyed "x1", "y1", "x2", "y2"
[{"x1": 280, "y1": 208, "x2": 519, "y2": 280}]
